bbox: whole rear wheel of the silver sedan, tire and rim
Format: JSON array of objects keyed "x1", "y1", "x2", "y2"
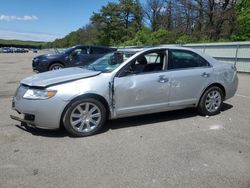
[{"x1": 198, "y1": 86, "x2": 223, "y2": 116}]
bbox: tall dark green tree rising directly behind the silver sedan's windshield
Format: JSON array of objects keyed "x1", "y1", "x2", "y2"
[{"x1": 91, "y1": 0, "x2": 142, "y2": 45}]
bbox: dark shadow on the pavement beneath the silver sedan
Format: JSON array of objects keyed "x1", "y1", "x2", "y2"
[{"x1": 16, "y1": 103, "x2": 233, "y2": 138}]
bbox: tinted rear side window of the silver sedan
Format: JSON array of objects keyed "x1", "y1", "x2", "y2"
[{"x1": 168, "y1": 50, "x2": 209, "y2": 69}]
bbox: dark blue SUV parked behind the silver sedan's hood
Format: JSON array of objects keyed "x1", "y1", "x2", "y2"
[{"x1": 32, "y1": 45, "x2": 116, "y2": 72}]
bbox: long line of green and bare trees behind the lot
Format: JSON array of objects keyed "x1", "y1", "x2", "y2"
[{"x1": 44, "y1": 0, "x2": 250, "y2": 48}]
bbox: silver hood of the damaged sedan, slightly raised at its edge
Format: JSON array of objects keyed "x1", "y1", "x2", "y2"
[{"x1": 21, "y1": 67, "x2": 101, "y2": 87}]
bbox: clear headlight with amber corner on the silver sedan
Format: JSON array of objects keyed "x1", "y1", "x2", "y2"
[{"x1": 23, "y1": 89, "x2": 56, "y2": 100}]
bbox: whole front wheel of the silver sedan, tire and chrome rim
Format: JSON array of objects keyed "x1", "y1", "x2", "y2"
[{"x1": 63, "y1": 98, "x2": 106, "y2": 137}]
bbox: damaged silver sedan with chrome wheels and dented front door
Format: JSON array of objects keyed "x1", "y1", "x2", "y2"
[{"x1": 11, "y1": 47, "x2": 238, "y2": 136}]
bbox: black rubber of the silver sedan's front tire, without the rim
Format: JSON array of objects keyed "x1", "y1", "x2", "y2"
[{"x1": 63, "y1": 98, "x2": 106, "y2": 137}]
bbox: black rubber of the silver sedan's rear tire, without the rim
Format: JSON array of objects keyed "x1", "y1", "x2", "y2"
[{"x1": 198, "y1": 86, "x2": 224, "y2": 116}]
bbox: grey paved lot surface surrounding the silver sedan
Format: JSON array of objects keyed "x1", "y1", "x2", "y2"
[{"x1": 0, "y1": 53, "x2": 250, "y2": 188}]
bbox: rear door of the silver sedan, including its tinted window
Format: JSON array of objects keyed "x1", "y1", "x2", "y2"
[{"x1": 168, "y1": 50, "x2": 213, "y2": 106}]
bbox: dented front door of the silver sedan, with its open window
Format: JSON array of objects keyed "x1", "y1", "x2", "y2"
[{"x1": 114, "y1": 50, "x2": 170, "y2": 117}]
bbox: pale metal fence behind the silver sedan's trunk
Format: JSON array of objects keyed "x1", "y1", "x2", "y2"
[{"x1": 183, "y1": 41, "x2": 250, "y2": 73}]
